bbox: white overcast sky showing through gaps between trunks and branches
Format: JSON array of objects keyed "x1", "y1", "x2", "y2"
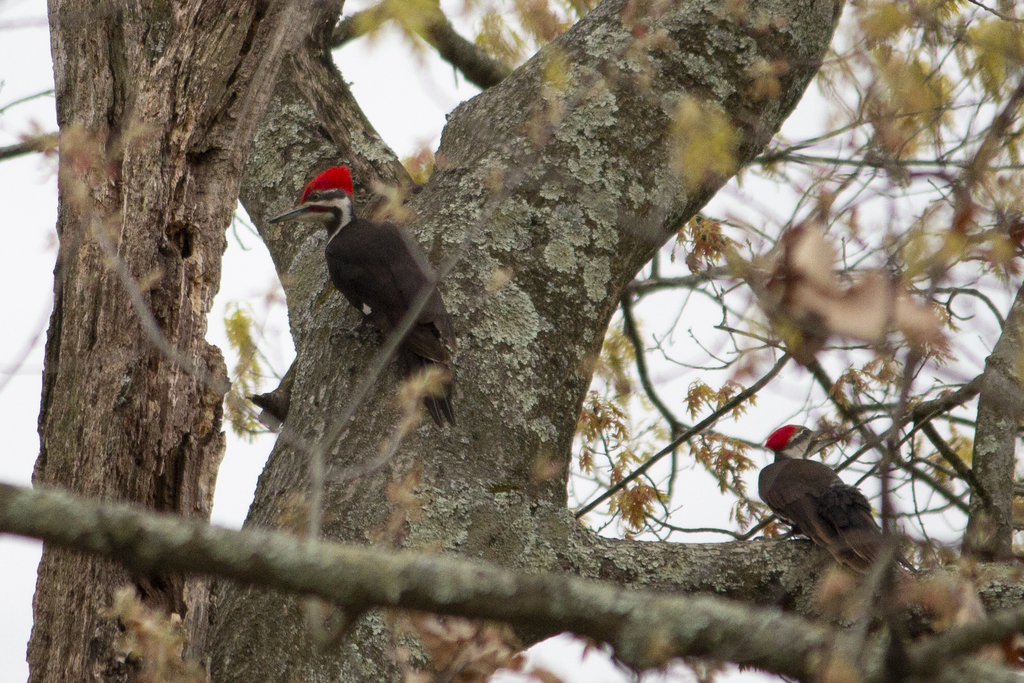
[{"x1": 0, "y1": 0, "x2": 999, "y2": 683}]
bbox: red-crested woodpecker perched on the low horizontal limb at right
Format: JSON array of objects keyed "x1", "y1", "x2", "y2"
[{"x1": 758, "y1": 425, "x2": 912, "y2": 571}]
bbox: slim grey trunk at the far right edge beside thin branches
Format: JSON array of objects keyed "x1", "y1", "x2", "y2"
[{"x1": 964, "y1": 288, "x2": 1024, "y2": 560}]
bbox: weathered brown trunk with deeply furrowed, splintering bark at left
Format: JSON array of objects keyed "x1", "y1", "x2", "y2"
[{"x1": 29, "y1": 0, "x2": 329, "y2": 682}]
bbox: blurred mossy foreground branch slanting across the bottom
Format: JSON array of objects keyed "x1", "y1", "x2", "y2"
[{"x1": 0, "y1": 484, "x2": 1022, "y2": 681}]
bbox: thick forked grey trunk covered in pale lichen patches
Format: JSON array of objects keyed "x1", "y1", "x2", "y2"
[{"x1": 210, "y1": 0, "x2": 839, "y2": 681}]
